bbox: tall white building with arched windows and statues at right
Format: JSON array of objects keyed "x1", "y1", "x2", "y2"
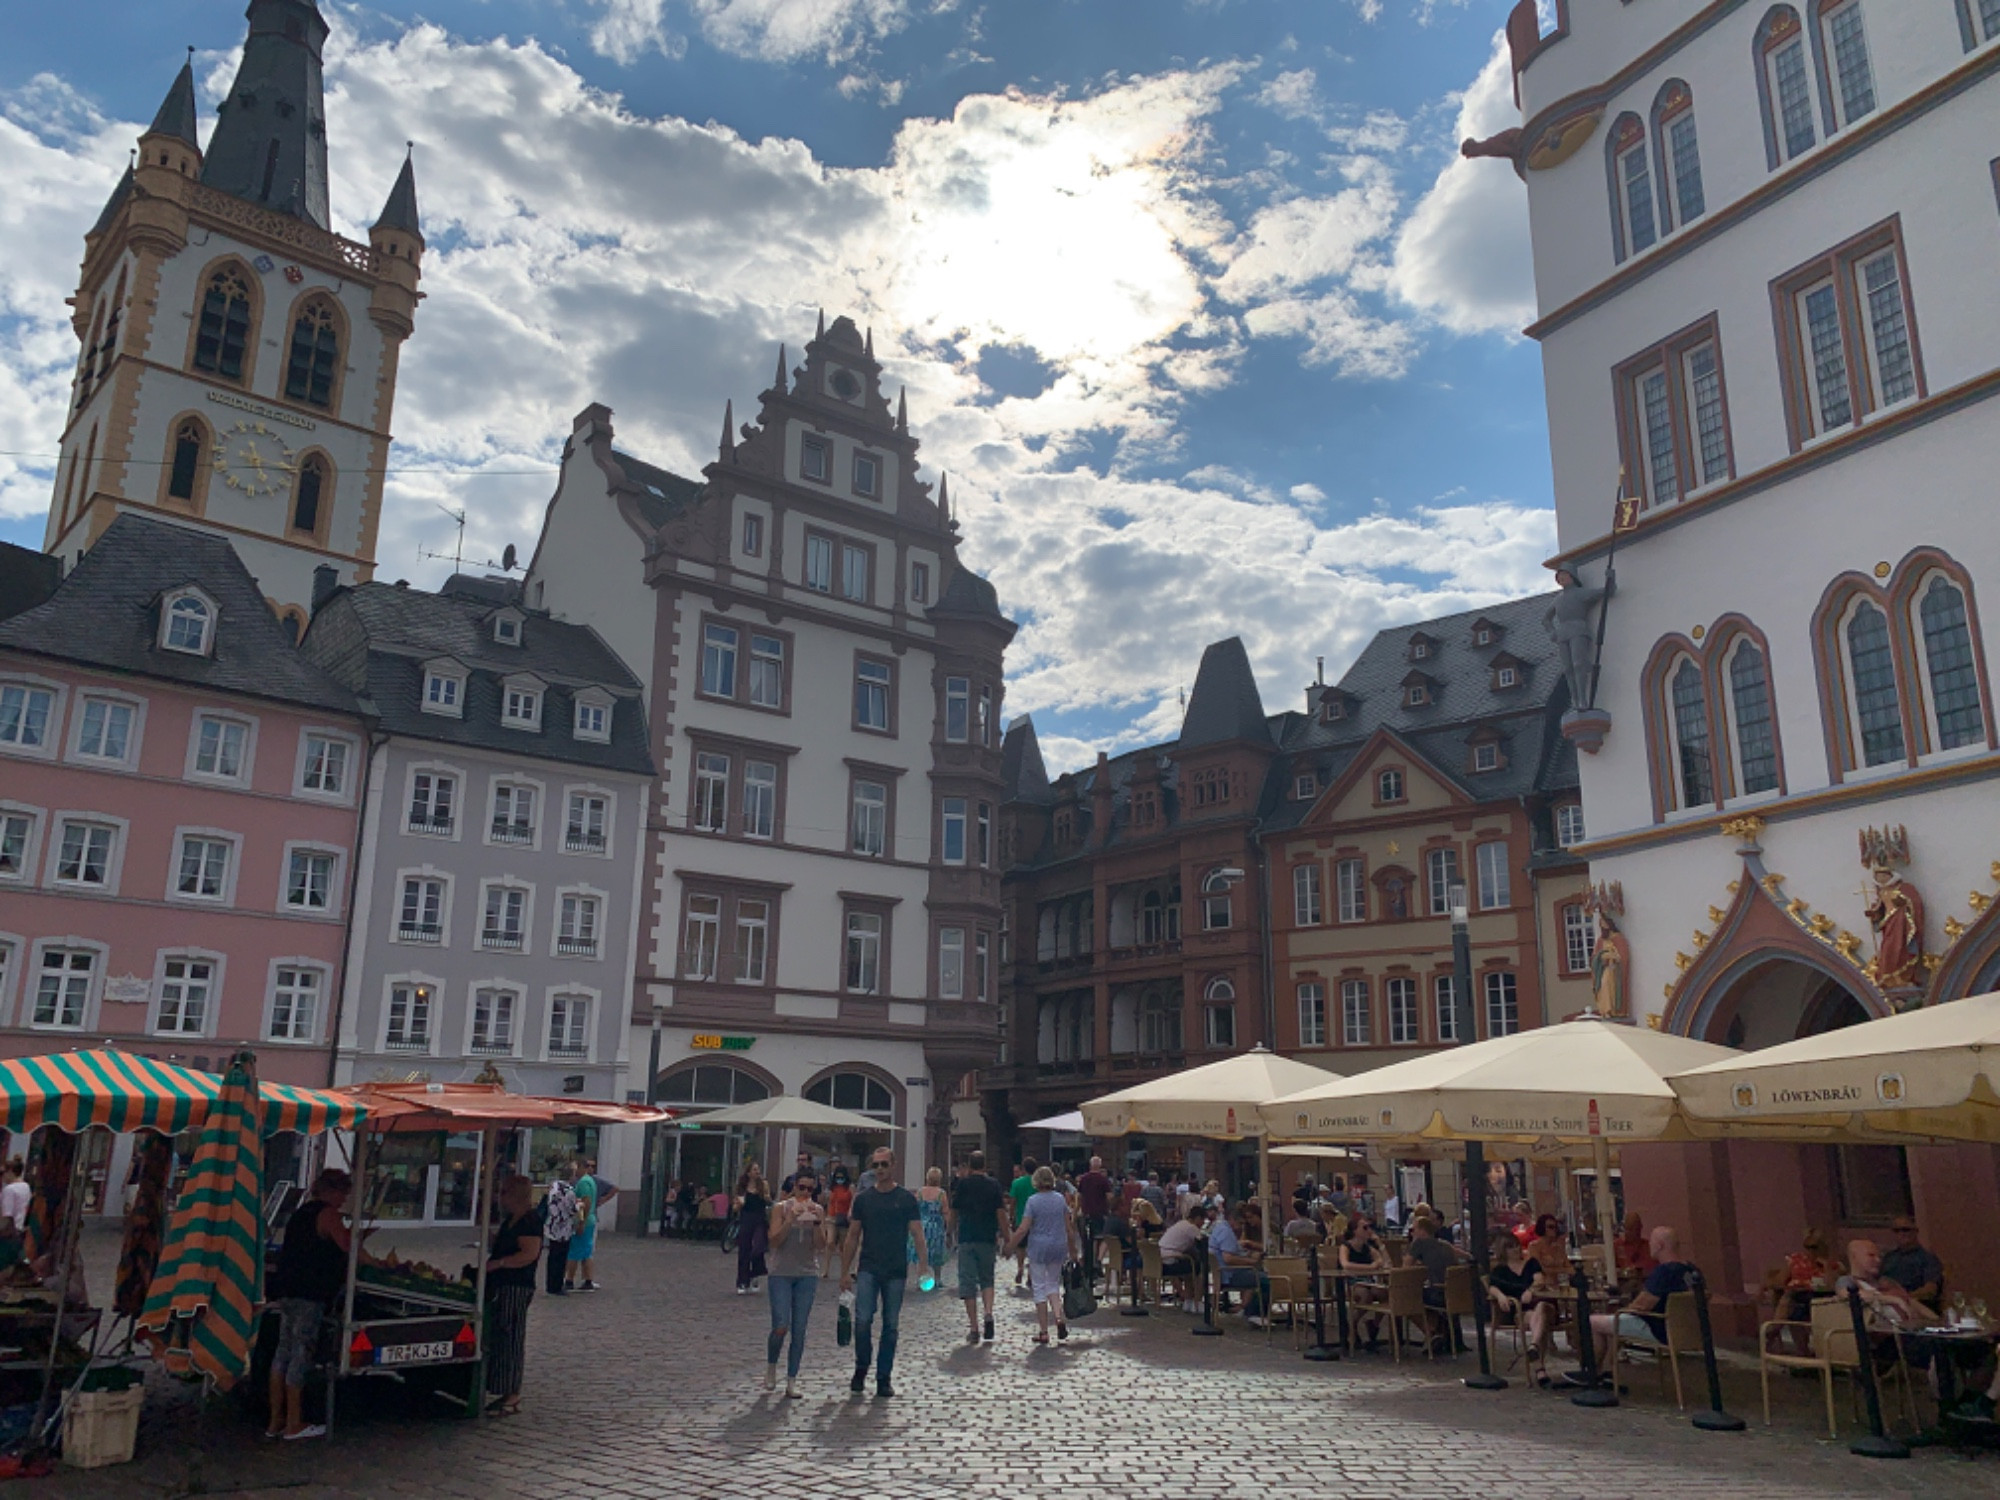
[{"x1": 1496, "y1": 0, "x2": 2000, "y2": 1312}]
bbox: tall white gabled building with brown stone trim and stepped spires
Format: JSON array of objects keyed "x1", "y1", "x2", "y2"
[{"x1": 526, "y1": 318, "x2": 1014, "y2": 1182}]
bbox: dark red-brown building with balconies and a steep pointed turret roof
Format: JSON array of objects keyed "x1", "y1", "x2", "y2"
[{"x1": 980, "y1": 636, "x2": 1278, "y2": 1168}]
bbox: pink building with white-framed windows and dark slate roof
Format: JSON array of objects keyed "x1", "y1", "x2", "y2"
[{"x1": 0, "y1": 518, "x2": 368, "y2": 1120}]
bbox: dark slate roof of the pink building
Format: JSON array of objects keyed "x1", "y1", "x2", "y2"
[{"x1": 0, "y1": 512, "x2": 360, "y2": 714}]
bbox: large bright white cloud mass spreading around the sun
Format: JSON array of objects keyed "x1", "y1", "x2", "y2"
[{"x1": 0, "y1": 17, "x2": 1552, "y2": 766}]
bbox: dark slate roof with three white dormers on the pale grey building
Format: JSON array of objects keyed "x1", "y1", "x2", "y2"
[{"x1": 302, "y1": 574, "x2": 652, "y2": 776}]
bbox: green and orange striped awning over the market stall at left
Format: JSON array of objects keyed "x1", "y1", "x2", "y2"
[{"x1": 0, "y1": 1048, "x2": 368, "y2": 1136}]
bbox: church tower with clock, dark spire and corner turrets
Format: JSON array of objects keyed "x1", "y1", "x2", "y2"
[{"x1": 42, "y1": 0, "x2": 424, "y2": 628}]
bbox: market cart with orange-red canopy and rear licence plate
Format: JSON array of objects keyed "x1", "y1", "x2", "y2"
[{"x1": 326, "y1": 1084, "x2": 670, "y2": 1428}]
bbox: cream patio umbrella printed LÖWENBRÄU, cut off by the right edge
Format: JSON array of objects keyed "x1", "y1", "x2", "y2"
[{"x1": 1668, "y1": 994, "x2": 2000, "y2": 1144}]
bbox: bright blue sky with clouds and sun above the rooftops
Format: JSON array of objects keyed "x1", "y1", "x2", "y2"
[{"x1": 0, "y1": 0, "x2": 1554, "y2": 772}]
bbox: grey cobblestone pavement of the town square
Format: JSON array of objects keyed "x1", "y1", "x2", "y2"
[{"x1": 31, "y1": 1232, "x2": 2000, "y2": 1500}]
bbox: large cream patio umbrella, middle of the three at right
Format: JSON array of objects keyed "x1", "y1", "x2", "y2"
[{"x1": 1262, "y1": 1012, "x2": 1736, "y2": 1280}]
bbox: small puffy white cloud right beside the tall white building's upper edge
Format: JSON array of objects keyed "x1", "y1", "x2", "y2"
[{"x1": 1390, "y1": 34, "x2": 1534, "y2": 334}]
